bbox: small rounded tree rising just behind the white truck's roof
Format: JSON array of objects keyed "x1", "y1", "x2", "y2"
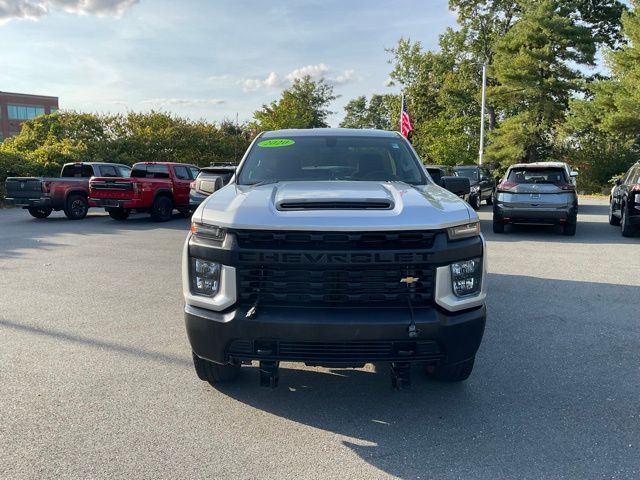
[{"x1": 253, "y1": 75, "x2": 338, "y2": 130}]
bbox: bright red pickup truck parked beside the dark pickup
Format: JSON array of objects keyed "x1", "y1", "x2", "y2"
[{"x1": 89, "y1": 162, "x2": 199, "y2": 222}]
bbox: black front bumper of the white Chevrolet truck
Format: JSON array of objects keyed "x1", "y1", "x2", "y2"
[{"x1": 185, "y1": 305, "x2": 486, "y2": 365}]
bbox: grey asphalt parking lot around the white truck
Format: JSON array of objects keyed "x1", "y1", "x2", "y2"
[{"x1": 0, "y1": 200, "x2": 640, "y2": 480}]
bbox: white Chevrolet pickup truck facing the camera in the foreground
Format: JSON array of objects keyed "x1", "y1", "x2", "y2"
[{"x1": 182, "y1": 128, "x2": 486, "y2": 387}]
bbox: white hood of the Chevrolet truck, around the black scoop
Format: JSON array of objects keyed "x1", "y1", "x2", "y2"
[{"x1": 193, "y1": 181, "x2": 478, "y2": 231}]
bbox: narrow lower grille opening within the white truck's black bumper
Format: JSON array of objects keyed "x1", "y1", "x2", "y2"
[{"x1": 227, "y1": 340, "x2": 443, "y2": 362}]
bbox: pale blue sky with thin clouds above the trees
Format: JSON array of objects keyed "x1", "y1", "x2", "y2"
[{"x1": 0, "y1": 0, "x2": 455, "y2": 125}]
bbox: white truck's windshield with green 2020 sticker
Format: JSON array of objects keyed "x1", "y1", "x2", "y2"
[{"x1": 238, "y1": 136, "x2": 426, "y2": 185}]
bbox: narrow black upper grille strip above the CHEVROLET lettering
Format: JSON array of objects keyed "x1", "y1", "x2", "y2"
[{"x1": 234, "y1": 230, "x2": 436, "y2": 251}]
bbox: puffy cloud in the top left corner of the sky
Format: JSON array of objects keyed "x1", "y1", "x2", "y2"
[{"x1": 0, "y1": 0, "x2": 140, "y2": 24}]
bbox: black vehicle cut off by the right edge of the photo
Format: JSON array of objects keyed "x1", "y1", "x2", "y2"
[{"x1": 609, "y1": 162, "x2": 640, "y2": 237}]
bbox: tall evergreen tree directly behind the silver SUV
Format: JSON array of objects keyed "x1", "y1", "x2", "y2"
[{"x1": 487, "y1": 0, "x2": 596, "y2": 165}]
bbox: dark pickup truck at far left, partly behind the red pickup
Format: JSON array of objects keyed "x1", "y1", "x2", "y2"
[{"x1": 5, "y1": 162, "x2": 131, "y2": 220}]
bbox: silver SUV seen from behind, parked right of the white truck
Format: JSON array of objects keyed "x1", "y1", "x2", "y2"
[{"x1": 493, "y1": 162, "x2": 578, "y2": 235}]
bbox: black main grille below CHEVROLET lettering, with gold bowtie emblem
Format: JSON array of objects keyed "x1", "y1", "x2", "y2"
[{"x1": 237, "y1": 265, "x2": 433, "y2": 307}]
